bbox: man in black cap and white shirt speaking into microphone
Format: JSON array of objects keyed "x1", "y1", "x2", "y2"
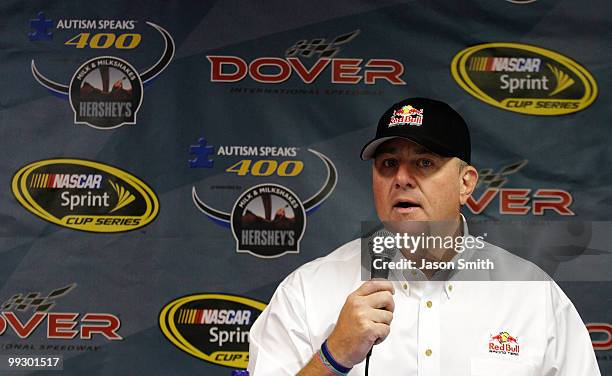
[{"x1": 248, "y1": 98, "x2": 600, "y2": 376}]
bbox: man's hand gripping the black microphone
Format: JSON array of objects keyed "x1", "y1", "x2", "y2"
[{"x1": 327, "y1": 280, "x2": 395, "y2": 368}]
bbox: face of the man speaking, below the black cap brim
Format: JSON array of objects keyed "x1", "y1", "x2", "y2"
[{"x1": 372, "y1": 138, "x2": 478, "y2": 221}]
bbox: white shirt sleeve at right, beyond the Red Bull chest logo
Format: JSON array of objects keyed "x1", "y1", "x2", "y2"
[{"x1": 541, "y1": 281, "x2": 601, "y2": 376}]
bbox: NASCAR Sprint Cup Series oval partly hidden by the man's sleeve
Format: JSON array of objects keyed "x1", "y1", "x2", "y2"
[{"x1": 159, "y1": 294, "x2": 266, "y2": 368}]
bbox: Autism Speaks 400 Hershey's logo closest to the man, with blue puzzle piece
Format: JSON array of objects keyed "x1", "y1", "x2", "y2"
[{"x1": 189, "y1": 138, "x2": 337, "y2": 258}]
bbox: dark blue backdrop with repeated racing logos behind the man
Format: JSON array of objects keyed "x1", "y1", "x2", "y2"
[{"x1": 0, "y1": 0, "x2": 612, "y2": 375}]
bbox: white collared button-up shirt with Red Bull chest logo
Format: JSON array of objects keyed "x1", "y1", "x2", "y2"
[{"x1": 248, "y1": 239, "x2": 600, "y2": 376}]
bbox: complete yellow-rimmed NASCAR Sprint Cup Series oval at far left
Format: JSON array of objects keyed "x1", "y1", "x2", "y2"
[{"x1": 12, "y1": 159, "x2": 159, "y2": 232}]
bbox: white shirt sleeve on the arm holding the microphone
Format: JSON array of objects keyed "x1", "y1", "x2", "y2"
[{"x1": 248, "y1": 275, "x2": 314, "y2": 376}]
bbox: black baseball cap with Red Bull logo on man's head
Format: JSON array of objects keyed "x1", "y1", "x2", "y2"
[{"x1": 361, "y1": 98, "x2": 471, "y2": 164}]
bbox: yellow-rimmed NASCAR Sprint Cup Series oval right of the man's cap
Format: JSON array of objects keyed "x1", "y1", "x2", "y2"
[{"x1": 451, "y1": 43, "x2": 597, "y2": 115}]
